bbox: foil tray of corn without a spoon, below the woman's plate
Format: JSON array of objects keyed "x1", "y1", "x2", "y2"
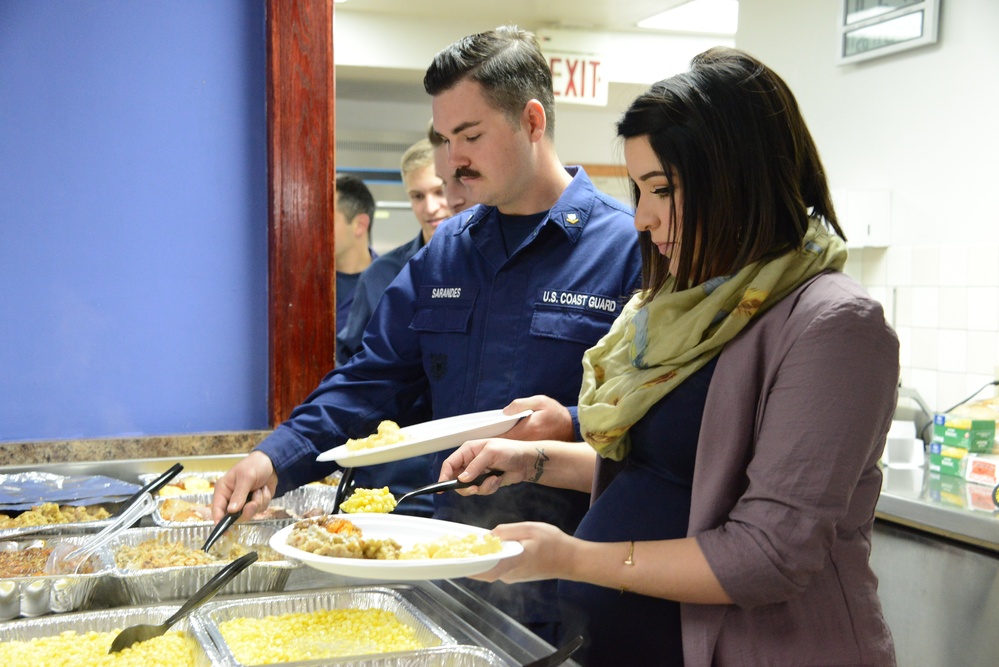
[{"x1": 192, "y1": 586, "x2": 472, "y2": 667}]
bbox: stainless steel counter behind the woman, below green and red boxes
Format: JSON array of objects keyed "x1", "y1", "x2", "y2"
[{"x1": 871, "y1": 467, "x2": 999, "y2": 666}]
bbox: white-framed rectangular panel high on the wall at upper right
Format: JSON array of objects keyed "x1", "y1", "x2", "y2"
[{"x1": 836, "y1": 0, "x2": 940, "y2": 65}]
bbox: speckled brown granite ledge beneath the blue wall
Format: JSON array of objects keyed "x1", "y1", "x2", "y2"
[{"x1": 0, "y1": 431, "x2": 270, "y2": 466}]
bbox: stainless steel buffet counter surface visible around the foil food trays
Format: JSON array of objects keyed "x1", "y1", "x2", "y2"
[{"x1": 0, "y1": 454, "x2": 576, "y2": 665}]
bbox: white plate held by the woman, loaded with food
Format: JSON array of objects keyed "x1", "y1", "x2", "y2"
[{"x1": 270, "y1": 514, "x2": 524, "y2": 581}]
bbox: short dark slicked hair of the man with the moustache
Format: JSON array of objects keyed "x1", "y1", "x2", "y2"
[{"x1": 423, "y1": 26, "x2": 555, "y2": 138}]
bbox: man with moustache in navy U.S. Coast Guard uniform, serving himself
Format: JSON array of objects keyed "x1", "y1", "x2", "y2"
[{"x1": 212, "y1": 27, "x2": 641, "y2": 643}]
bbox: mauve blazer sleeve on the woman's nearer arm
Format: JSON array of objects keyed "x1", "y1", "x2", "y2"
[{"x1": 697, "y1": 299, "x2": 899, "y2": 607}]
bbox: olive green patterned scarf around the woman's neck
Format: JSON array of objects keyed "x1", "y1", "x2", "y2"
[{"x1": 579, "y1": 219, "x2": 847, "y2": 461}]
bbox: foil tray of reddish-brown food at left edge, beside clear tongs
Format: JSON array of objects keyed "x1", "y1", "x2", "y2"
[{"x1": 0, "y1": 536, "x2": 111, "y2": 621}]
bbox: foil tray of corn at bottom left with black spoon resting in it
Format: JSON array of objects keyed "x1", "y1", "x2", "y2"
[{"x1": 0, "y1": 605, "x2": 214, "y2": 667}]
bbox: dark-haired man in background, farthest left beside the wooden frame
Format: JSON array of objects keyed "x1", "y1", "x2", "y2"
[{"x1": 333, "y1": 174, "x2": 377, "y2": 335}]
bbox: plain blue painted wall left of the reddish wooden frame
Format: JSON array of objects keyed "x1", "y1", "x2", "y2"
[{"x1": 0, "y1": 0, "x2": 267, "y2": 441}]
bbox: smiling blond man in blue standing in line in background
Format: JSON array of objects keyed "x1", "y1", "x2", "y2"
[{"x1": 336, "y1": 139, "x2": 458, "y2": 365}]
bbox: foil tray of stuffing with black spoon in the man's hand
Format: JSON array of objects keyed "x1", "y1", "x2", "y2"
[{"x1": 102, "y1": 522, "x2": 302, "y2": 604}]
